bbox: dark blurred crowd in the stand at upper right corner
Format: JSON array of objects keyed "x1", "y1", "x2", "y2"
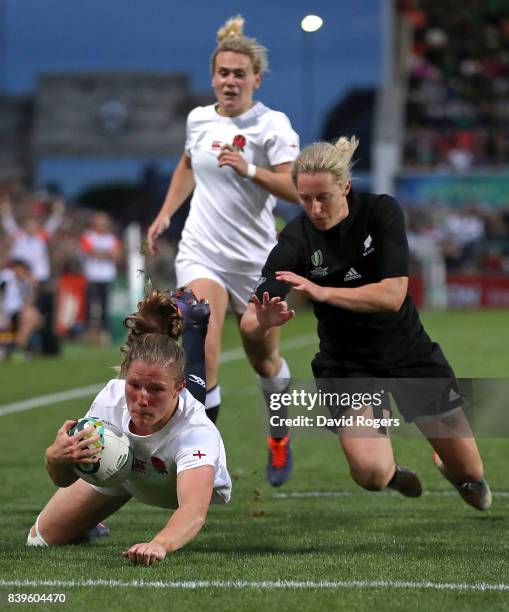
[{"x1": 398, "y1": 0, "x2": 509, "y2": 171}]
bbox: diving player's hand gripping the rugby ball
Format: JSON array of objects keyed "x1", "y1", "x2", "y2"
[{"x1": 46, "y1": 420, "x2": 101, "y2": 466}]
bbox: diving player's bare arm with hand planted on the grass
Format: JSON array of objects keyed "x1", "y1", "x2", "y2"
[{"x1": 122, "y1": 465, "x2": 214, "y2": 565}]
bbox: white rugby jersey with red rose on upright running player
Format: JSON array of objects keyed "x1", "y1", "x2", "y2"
[{"x1": 177, "y1": 102, "x2": 299, "y2": 275}]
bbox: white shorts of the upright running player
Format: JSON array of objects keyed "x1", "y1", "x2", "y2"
[{"x1": 175, "y1": 256, "x2": 259, "y2": 314}]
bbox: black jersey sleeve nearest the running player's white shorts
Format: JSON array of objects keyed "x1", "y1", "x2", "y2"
[{"x1": 253, "y1": 235, "x2": 299, "y2": 301}]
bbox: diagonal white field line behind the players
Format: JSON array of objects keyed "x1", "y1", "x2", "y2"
[{"x1": 0, "y1": 334, "x2": 316, "y2": 416}]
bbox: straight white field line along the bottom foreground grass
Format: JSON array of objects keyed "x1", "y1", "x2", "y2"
[{"x1": 0, "y1": 579, "x2": 509, "y2": 592}]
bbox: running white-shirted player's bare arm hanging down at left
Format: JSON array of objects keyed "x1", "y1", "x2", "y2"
[{"x1": 147, "y1": 153, "x2": 194, "y2": 255}]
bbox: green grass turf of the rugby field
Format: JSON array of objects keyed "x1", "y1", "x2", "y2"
[{"x1": 0, "y1": 309, "x2": 509, "y2": 611}]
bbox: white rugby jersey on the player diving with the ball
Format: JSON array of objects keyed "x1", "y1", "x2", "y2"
[{"x1": 87, "y1": 379, "x2": 232, "y2": 508}]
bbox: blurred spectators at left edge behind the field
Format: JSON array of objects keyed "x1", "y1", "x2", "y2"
[{"x1": 0, "y1": 190, "x2": 123, "y2": 361}]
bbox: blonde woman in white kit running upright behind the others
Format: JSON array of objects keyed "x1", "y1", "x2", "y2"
[{"x1": 148, "y1": 17, "x2": 299, "y2": 486}]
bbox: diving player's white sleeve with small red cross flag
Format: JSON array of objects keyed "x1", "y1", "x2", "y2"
[{"x1": 175, "y1": 426, "x2": 221, "y2": 474}]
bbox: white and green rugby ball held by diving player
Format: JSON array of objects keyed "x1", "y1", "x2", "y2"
[{"x1": 68, "y1": 417, "x2": 134, "y2": 487}]
